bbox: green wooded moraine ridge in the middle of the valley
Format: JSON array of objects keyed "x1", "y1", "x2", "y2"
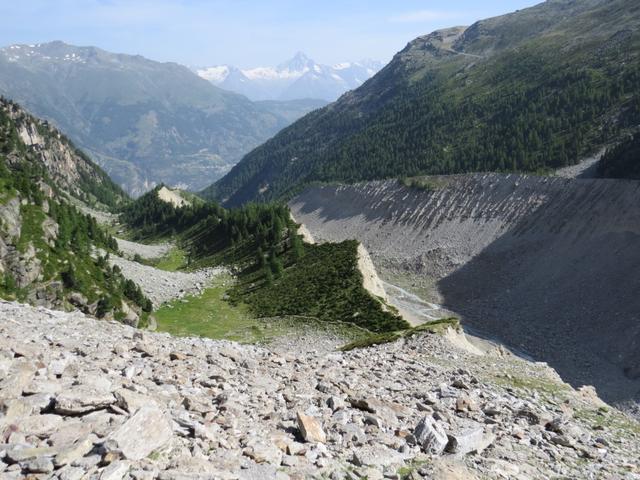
[{"x1": 122, "y1": 187, "x2": 408, "y2": 332}]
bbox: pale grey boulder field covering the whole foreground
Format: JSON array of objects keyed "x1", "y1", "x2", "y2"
[{"x1": 0, "y1": 302, "x2": 640, "y2": 480}]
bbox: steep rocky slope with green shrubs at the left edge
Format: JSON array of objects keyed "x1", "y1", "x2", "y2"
[{"x1": 0, "y1": 100, "x2": 151, "y2": 324}]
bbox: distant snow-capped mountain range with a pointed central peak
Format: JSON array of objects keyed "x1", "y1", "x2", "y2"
[{"x1": 196, "y1": 52, "x2": 384, "y2": 102}]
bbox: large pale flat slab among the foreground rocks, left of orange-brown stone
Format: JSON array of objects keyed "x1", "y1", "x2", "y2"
[{"x1": 108, "y1": 406, "x2": 173, "y2": 460}]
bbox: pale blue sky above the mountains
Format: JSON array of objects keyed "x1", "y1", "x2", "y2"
[{"x1": 0, "y1": 0, "x2": 539, "y2": 67}]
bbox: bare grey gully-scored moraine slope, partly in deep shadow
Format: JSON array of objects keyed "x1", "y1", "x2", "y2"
[{"x1": 290, "y1": 174, "x2": 640, "y2": 410}]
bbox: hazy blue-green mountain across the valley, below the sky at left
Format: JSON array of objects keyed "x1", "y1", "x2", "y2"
[{"x1": 0, "y1": 42, "x2": 319, "y2": 194}]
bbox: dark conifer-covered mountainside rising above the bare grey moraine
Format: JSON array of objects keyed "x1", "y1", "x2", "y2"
[{"x1": 206, "y1": 0, "x2": 640, "y2": 204}]
